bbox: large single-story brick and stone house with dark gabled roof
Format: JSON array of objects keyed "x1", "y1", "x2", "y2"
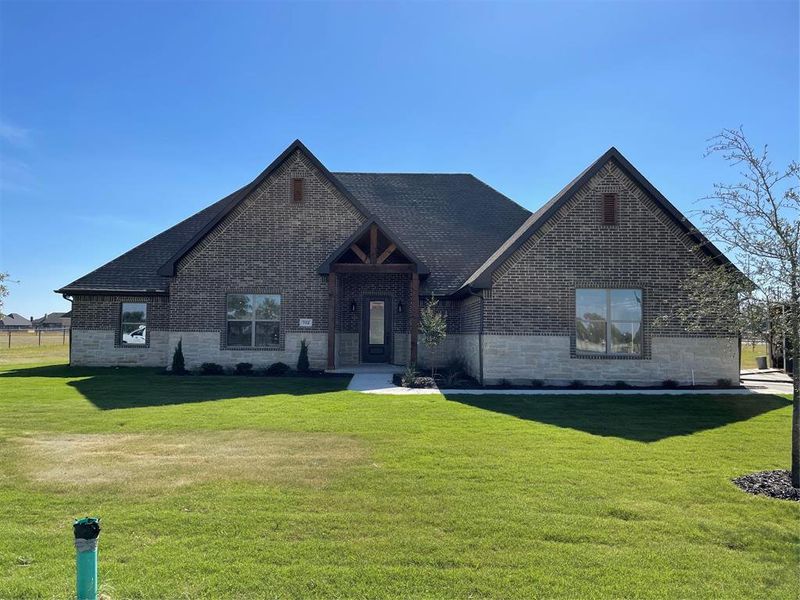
[{"x1": 57, "y1": 141, "x2": 739, "y2": 384}]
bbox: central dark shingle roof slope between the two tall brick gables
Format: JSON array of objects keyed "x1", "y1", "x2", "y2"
[{"x1": 333, "y1": 173, "x2": 530, "y2": 294}]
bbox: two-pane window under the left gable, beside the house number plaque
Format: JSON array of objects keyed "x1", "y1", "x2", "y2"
[{"x1": 226, "y1": 294, "x2": 281, "y2": 347}]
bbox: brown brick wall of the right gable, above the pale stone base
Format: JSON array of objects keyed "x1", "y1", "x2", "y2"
[{"x1": 484, "y1": 162, "x2": 729, "y2": 356}]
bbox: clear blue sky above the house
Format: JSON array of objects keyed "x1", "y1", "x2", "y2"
[{"x1": 0, "y1": 1, "x2": 798, "y2": 316}]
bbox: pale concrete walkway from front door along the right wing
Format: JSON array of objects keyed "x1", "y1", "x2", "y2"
[{"x1": 332, "y1": 364, "x2": 780, "y2": 396}]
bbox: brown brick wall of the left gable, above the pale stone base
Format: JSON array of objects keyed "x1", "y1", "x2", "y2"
[{"x1": 170, "y1": 152, "x2": 364, "y2": 347}]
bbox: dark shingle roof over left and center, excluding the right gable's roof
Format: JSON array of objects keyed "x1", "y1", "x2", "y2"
[{"x1": 57, "y1": 141, "x2": 530, "y2": 294}]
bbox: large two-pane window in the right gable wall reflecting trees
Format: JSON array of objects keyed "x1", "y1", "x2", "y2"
[{"x1": 575, "y1": 289, "x2": 642, "y2": 355}]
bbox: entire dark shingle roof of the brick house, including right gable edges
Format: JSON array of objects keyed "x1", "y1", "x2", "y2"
[{"x1": 57, "y1": 140, "x2": 730, "y2": 294}]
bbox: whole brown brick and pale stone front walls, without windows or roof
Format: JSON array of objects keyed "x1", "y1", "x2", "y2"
[{"x1": 72, "y1": 151, "x2": 738, "y2": 382}]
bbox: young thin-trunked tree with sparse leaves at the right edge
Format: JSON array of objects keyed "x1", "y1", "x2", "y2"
[{"x1": 683, "y1": 128, "x2": 800, "y2": 488}]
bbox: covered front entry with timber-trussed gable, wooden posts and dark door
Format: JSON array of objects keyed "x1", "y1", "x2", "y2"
[{"x1": 319, "y1": 221, "x2": 428, "y2": 369}]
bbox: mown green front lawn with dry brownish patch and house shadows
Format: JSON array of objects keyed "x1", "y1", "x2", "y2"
[{"x1": 0, "y1": 358, "x2": 800, "y2": 599}]
